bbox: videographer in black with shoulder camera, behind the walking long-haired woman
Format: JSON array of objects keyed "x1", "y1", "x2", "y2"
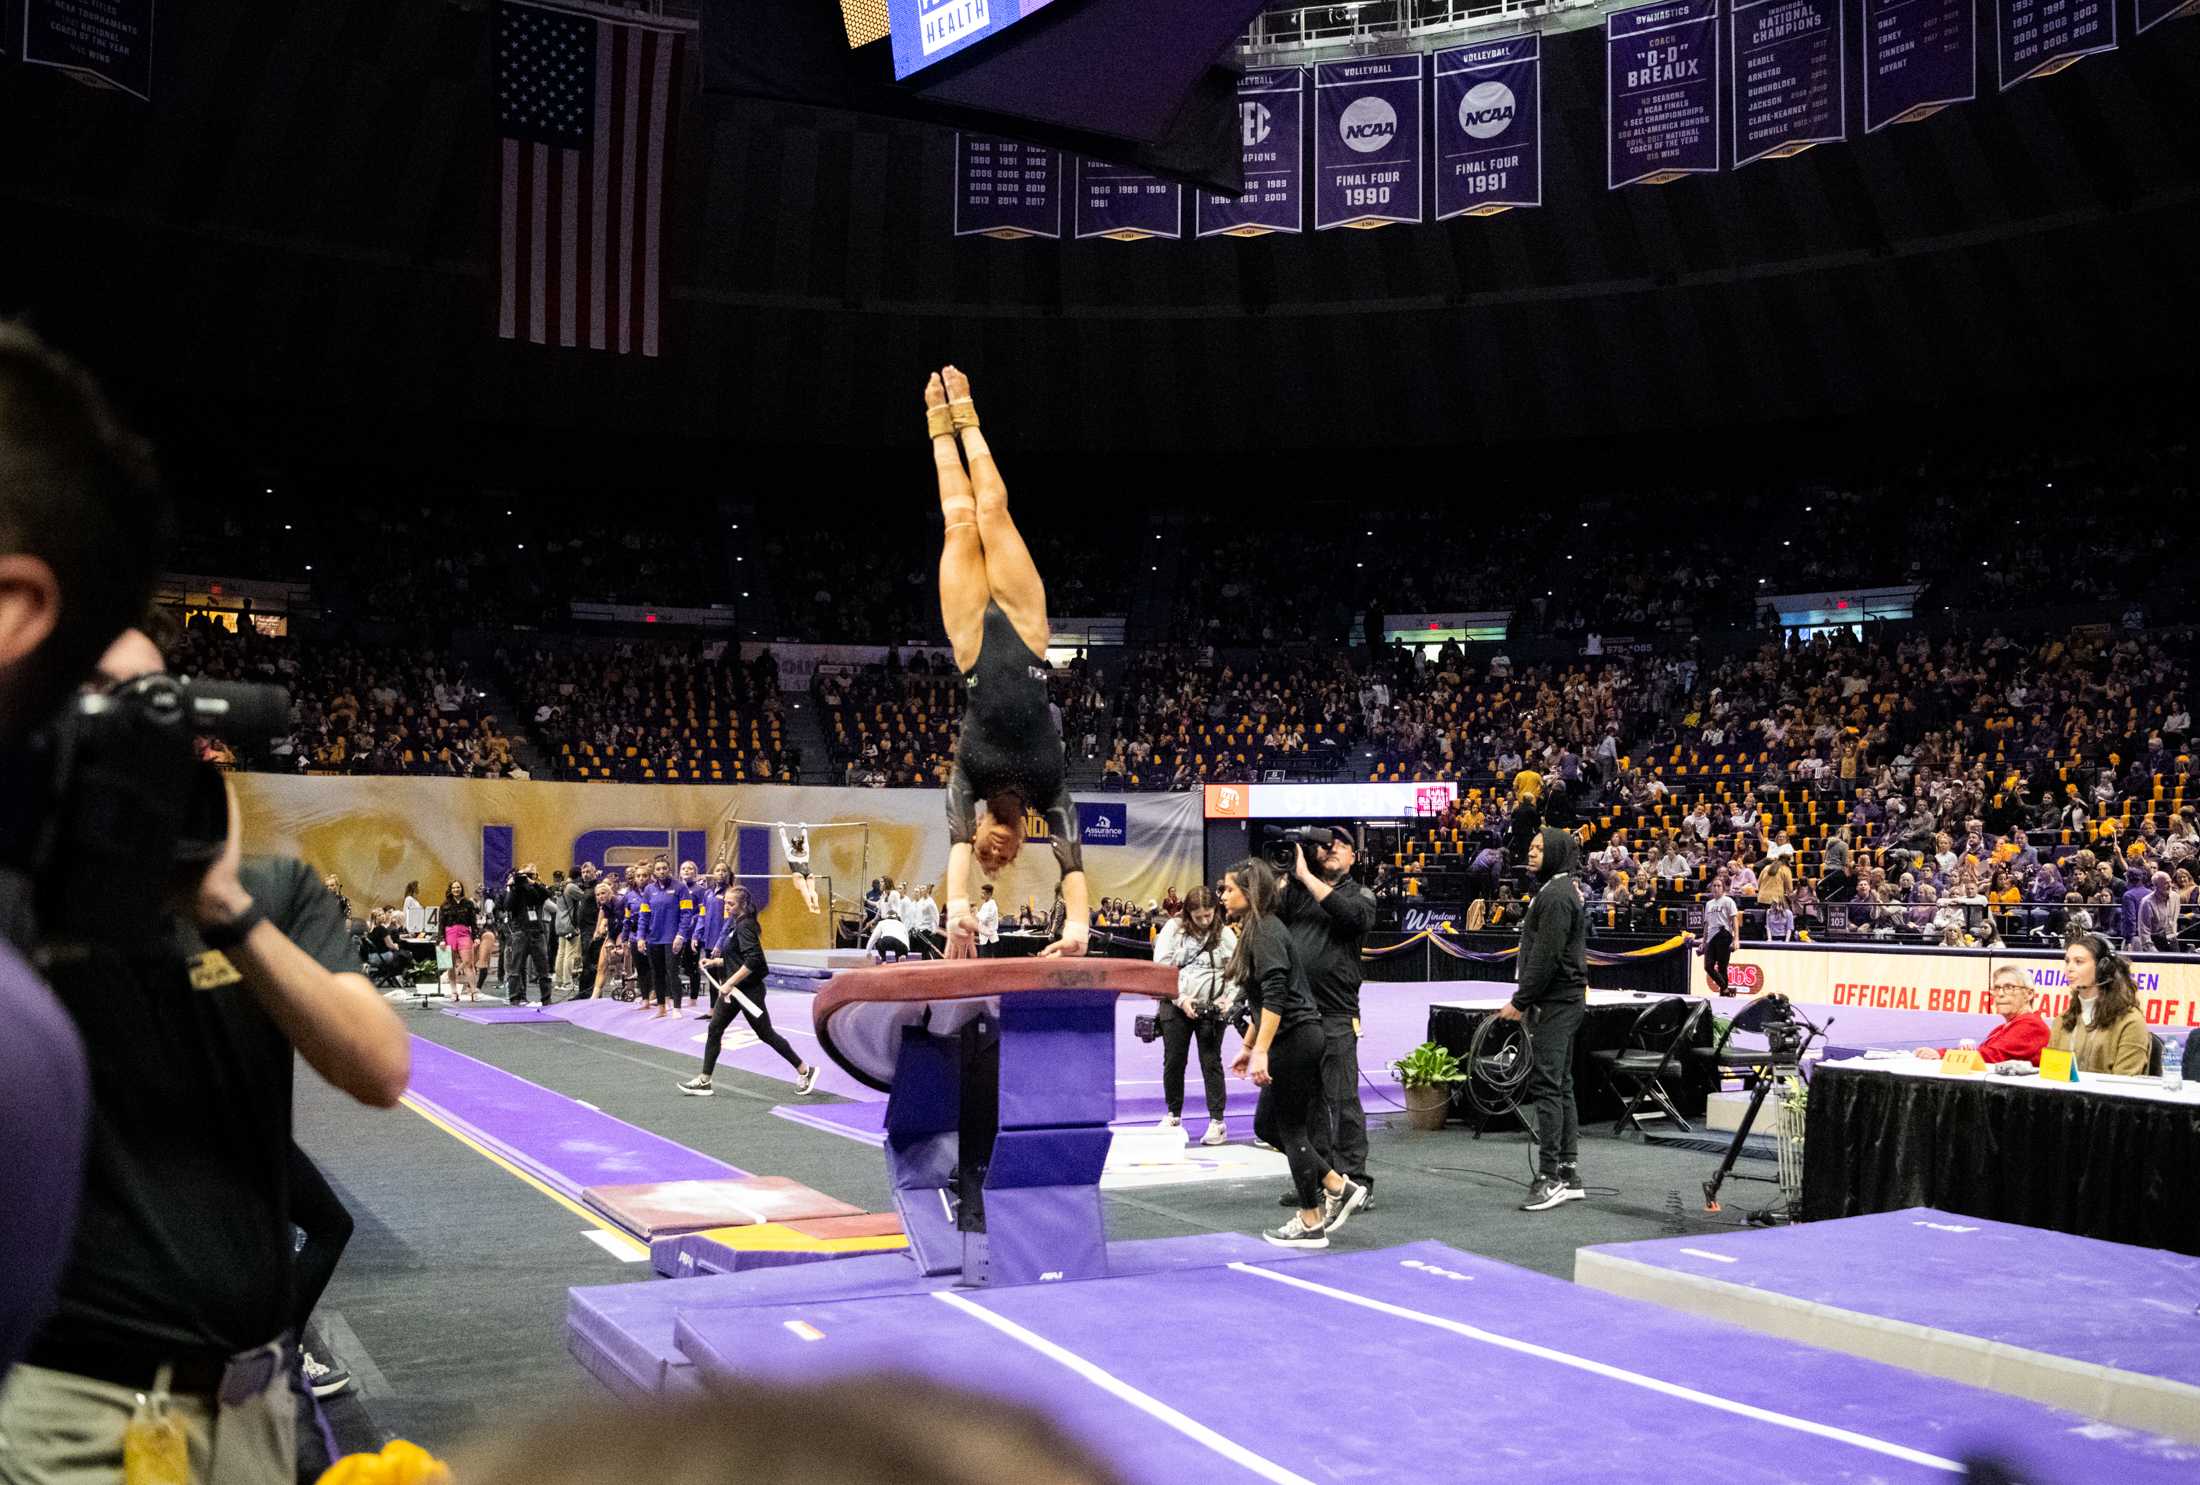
[{"x1": 1276, "y1": 825, "x2": 1375, "y2": 1212}]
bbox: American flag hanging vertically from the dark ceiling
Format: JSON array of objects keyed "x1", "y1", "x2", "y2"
[{"x1": 497, "y1": 0, "x2": 680, "y2": 356}]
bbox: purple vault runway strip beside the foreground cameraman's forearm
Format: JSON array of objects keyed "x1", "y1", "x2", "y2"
[{"x1": 407, "y1": 1036, "x2": 748, "y2": 1201}]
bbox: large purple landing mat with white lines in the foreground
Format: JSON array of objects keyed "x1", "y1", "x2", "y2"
[{"x1": 678, "y1": 1243, "x2": 2200, "y2": 1485}]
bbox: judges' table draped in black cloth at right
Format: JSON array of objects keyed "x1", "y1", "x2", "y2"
[{"x1": 1802, "y1": 1060, "x2": 2200, "y2": 1254}]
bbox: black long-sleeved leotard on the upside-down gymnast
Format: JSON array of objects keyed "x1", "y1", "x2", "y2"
[{"x1": 948, "y1": 603, "x2": 1085, "y2": 876}]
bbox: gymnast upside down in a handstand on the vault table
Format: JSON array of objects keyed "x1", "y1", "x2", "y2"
[{"x1": 924, "y1": 365, "x2": 1091, "y2": 959}]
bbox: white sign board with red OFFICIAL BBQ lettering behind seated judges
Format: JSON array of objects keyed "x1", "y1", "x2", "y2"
[{"x1": 1727, "y1": 944, "x2": 2200, "y2": 1030}]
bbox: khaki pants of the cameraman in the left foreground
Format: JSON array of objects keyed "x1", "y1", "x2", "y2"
[{"x1": 0, "y1": 1349, "x2": 297, "y2": 1485}]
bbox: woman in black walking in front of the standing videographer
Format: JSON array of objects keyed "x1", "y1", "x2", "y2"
[{"x1": 1221, "y1": 860, "x2": 1368, "y2": 1247}]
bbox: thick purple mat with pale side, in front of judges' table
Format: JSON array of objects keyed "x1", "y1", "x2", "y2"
[{"x1": 1575, "y1": 1208, "x2": 2200, "y2": 1443}]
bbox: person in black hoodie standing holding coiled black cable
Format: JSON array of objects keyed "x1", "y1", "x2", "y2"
[{"x1": 1498, "y1": 829, "x2": 1588, "y2": 1212}]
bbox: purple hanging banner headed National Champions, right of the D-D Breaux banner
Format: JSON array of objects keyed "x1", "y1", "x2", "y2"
[{"x1": 1727, "y1": 0, "x2": 1848, "y2": 169}]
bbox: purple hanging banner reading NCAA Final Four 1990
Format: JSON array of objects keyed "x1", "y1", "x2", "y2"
[{"x1": 1313, "y1": 53, "x2": 1421, "y2": 231}]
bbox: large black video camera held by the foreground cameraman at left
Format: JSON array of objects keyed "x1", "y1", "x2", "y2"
[{"x1": 0, "y1": 673, "x2": 290, "y2": 944}]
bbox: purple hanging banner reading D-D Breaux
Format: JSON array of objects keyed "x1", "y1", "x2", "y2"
[{"x1": 1604, "y1": 0, "x2": 1720, "y2": 191}]
